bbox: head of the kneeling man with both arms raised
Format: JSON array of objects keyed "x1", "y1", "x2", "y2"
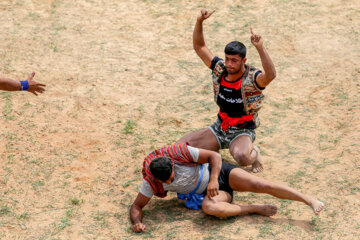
[{"x1": 225, "y1": 41, "x2": 246, "y2": 74}]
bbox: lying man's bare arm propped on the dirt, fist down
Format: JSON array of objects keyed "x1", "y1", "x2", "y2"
[{"x1": 130, "y1": 193, "x2": 150, "y2": 233}]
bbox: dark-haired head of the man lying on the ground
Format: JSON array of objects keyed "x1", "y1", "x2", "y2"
[{"x1": 150, "y1": 157, "x2": 172, "y2": 182}]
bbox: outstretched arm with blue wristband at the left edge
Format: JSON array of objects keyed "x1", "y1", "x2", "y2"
[{"x1": 0, "y1": 72, "x2": 46, "y2": 96}]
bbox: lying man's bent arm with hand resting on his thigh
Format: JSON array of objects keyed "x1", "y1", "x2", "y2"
[{"x1": 198, "y1": 149, "x2": 222, "y2": 197}]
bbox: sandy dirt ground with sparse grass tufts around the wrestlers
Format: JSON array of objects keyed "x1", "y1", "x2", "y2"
[{"x1": 0, "y1": 0, "x2": 360, "y2": 240}]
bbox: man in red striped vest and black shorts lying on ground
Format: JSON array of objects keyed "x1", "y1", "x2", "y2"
[{"x1": 130, "y1": 144, "x2": 324, "y2": 232}]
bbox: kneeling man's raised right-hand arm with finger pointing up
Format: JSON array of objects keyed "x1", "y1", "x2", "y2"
[{"x1": 250, "y1": 27, "x2": 276, "y2": 87}]
